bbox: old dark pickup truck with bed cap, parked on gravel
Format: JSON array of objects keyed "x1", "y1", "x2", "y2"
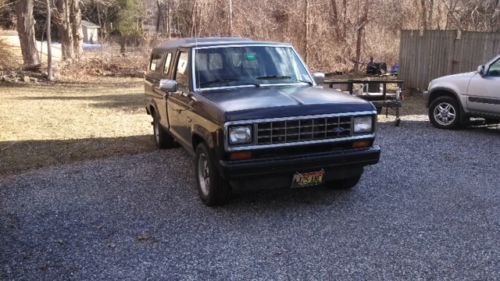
[{"x1": 145, "y1": 37, "x2": 380, "y2": 206}]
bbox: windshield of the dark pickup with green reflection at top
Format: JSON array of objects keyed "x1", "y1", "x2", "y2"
[{"x1": 194, "y1": 46, "x2": 312, "y2": 89}]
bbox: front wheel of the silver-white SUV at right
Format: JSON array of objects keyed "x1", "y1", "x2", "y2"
[{"x1": 429, "y1": 96, "x2": 462, "y2": 130}]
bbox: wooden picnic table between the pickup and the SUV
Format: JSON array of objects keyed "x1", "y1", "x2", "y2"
[{"x1": 324, "y1": 77, "x2": 404, "y2": 126}]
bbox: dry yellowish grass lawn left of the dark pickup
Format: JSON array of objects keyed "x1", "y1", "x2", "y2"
[{"x1": 0, "y1": 78, "x2": 154, "y2": 176}]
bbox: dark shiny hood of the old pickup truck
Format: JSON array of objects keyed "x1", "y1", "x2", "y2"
[{"x1": 201, "y1": 86, "x2": 375, "y2": 121}]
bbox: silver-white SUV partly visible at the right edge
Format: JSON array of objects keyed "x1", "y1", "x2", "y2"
[{"x1": 424, "y1": 55, "x2": 500, "y2": 129}]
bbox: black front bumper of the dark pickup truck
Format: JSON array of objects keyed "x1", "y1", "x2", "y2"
[{"x1": 219, "y1": 145, "x2": 380, "y2": 180}]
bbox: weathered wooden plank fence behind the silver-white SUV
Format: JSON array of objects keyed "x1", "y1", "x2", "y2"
[{"x1": 399, "y1": 30, "x2": 500, "y2": 91}]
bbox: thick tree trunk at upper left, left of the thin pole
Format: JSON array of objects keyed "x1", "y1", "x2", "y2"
[{"x1": 16, "y1": 0, "x2": 40, "y2": 70}]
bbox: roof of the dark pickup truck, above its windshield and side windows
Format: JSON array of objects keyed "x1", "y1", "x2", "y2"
[{"x1": 155, "y1": 37, "x2": 289, "y2": 51}]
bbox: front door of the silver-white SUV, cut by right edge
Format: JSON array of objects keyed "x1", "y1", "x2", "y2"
[{"x1": 467, "y1": 58, "x2": 500, "y2": 116}]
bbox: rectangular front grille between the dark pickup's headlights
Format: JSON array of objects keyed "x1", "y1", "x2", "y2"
[{"x1": 256, "y1": 116, "x2": 352, "y2": 145}]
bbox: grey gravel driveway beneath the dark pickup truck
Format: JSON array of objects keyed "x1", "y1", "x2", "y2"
[{"x1": 0, "y1": 117, "x2": 500, "y2": 280}]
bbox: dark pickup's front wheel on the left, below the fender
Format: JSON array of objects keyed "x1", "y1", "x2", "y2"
[{"x1": 194, "y1": 143, "x2": 231, "y2": 206}]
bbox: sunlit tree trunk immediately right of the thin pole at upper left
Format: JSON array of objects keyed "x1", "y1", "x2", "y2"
[{"x1": 56, "y1": 0, "x2": 75, "y2": 60}]
